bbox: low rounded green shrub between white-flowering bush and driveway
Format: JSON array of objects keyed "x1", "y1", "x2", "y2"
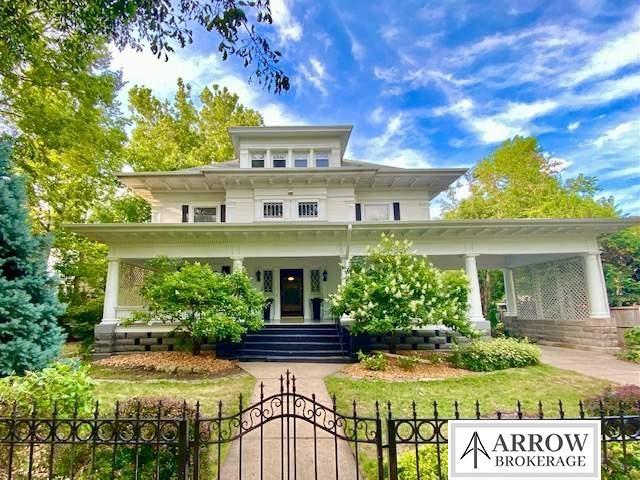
[{"x1": 452, "y1": 338, "x2": 540, "y2": 372}]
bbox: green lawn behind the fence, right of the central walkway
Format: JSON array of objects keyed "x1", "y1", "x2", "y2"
[{"x1": 326, "y1": 365, "x2": 608, "y2": 417}]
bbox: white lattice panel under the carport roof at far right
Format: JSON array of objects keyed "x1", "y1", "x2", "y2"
[{"x1": 514, "y1": 258, "x2": 589, "y2": 320}]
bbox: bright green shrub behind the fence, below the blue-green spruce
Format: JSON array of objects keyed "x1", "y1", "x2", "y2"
[{"x1": 0, "y1": 360, "x2": 95, "y2": 417}]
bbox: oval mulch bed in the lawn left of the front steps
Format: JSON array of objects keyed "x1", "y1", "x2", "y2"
[{"x1": 94, "y1": 352, "x2": 239, "y2": 376}]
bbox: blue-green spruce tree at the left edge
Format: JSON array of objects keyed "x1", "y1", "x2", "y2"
[{"x1": 0, "y1": 143, "x2": 64, "y2": 376}]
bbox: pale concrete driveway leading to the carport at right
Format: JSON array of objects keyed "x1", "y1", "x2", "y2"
[{"x1": 540, "y1": 345, "x2": 640, "y2": 385}]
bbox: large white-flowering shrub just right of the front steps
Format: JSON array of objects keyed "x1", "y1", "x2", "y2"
[{"x1": 331, "y1": 235, "x2": 475, "y2": 351}]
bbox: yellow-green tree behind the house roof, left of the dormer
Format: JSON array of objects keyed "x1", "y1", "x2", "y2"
[{"x1": 124, "y1": 79, "x2": 263, "y2": 171}]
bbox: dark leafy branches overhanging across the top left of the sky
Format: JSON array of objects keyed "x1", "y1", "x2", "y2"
[{"x1": 0, "y1": 0, "x2": 289, "y2": 93}]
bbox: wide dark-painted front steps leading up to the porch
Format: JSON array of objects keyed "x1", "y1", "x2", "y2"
[{"x1": 237, "y1": 323, "x2": 352, "y2": 363}]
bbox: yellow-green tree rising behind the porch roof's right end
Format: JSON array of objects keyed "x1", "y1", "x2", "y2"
[{"x1": 444, "y1": 136, "x2": 617, "y2": 318}]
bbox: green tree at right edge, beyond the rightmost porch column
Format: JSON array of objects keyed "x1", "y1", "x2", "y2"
[{"x1": 602, "y1": 228, "x2": 640, "y2": 307}]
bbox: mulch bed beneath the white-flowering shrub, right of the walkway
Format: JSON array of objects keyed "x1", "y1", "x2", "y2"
[{"x1": 341, "y1": 357, "x2": 473, "y2": 381}]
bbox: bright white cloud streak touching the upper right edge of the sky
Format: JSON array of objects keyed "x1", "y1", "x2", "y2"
[{"x1": 562, "y1": 31, "x2": 640, "y2": 85}]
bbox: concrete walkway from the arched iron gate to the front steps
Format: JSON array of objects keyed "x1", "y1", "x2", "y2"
[{"x1": 221, "y1": 362, "x2": 356, "y2": 480}]
